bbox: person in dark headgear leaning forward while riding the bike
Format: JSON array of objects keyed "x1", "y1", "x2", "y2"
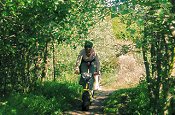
[{"x1": 75, "y1": 41, "x2": 100, "y2": 90}]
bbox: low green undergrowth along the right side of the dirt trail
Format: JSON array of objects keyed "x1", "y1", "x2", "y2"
[{"x1": 104, "y1": 83, "x2": 150, "y2": 115}]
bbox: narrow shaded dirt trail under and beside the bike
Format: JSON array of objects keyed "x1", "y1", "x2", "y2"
[{"x1": 64, "y1": 87, "x2": 114, "y2": 115}]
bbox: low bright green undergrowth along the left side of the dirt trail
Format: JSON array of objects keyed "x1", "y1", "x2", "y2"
[{"x1": 0, "y1": 82, "x2": 81, "y2": 115}]
